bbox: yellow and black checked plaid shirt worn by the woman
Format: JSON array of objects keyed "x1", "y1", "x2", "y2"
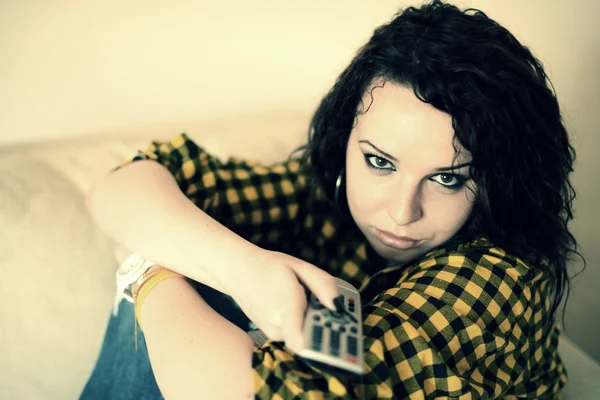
[{"x1": 123, "y1": 134, "x2": 566, "y2": 399}]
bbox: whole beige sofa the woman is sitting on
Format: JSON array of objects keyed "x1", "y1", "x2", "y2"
[{"x1": 0, "y1": 111, "x2": 600, "y2": 400}]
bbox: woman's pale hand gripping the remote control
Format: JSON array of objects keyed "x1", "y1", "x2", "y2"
[{"x1": 228, "y1": 249, "x2": 338, "y2": 352}]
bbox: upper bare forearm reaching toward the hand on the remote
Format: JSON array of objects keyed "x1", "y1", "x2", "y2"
[{"x1": 87, "y1": 161, "x2": 257, "y2": 293}]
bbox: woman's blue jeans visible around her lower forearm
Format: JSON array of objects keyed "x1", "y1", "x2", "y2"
[{"x1": 80, "y1": 282, "x2": 252, "y2": 400}]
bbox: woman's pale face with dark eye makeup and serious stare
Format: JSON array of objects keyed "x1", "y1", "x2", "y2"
[{"x1": 346, "y1": 82, "x2": 476, "y2": 263}]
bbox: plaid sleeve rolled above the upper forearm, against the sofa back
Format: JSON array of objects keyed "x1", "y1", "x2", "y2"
[{"x1": 115, "y1": 133, "x2": 309, "y2": 246}]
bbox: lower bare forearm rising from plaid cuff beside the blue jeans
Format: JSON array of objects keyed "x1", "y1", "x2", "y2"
[{"x1": 141, "y1": 278, "x2": 254, "y2": 400}]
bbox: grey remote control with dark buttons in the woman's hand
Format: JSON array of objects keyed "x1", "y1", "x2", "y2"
[{"x1": 298, "y1": 278, "x2": 364, "y2": 374}]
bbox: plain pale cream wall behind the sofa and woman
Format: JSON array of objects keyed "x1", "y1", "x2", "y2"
[{"x1": 0, "y1": 0, "x2": 600, "y2": 360}]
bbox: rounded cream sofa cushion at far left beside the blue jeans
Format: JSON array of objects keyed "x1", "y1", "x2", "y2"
[{"x1": 0, "y1": 155, "x2": 116, "y2": 399}]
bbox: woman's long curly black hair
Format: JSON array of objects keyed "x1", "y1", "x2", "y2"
[{"x1": 303, "y1": 1, "x2": 581, "y2": 315}]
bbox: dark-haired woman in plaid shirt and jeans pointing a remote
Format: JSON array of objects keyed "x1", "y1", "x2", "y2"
[{"x1": 82, "y1": 2, "x2": 577, "y2": 400}]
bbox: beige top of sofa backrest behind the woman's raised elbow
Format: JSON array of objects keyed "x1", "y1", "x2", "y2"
[{"x1": 18, "y1": 110, "x2": 309, "y2": 196}]
